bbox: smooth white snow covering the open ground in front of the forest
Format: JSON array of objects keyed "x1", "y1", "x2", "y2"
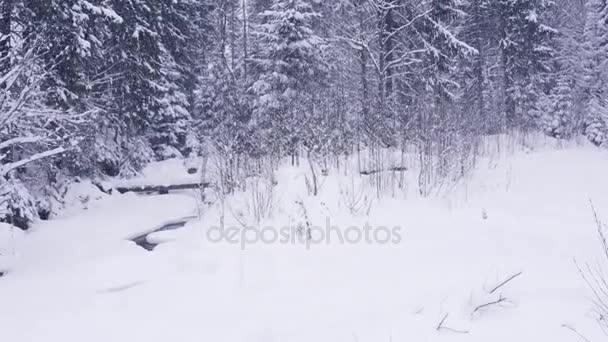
[{"x1": 0, "y1": 138, "x2": 608, "y2": 342}]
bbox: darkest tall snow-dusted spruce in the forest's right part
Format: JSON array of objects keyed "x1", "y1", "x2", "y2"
[{"x1": 496, "y1": 0, "x2": 556, "y2": 128}]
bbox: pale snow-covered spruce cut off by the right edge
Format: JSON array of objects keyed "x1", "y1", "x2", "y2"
[{"x1": 583, "y1": 0, "x2": 608, "y2": 145}]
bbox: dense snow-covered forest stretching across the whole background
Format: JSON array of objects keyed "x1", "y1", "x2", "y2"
[{"x1": 0, "y1": 0, "x2": 608, "y2": 227}]
